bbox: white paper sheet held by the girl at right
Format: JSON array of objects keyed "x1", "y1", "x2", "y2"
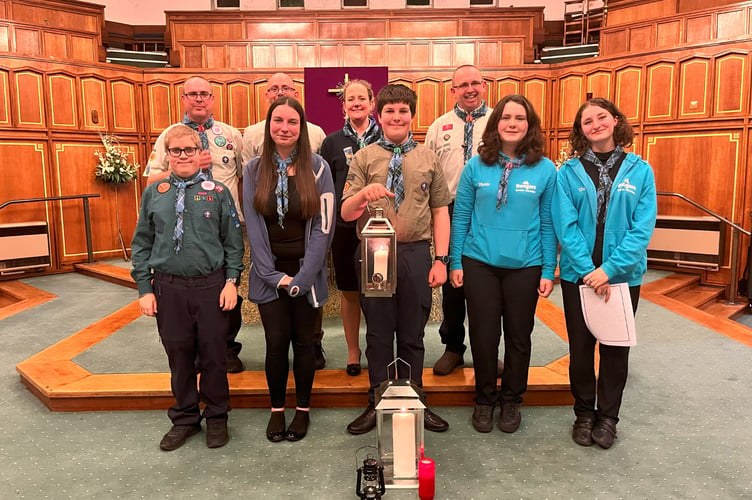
[{"x1": 580, "y1": 283, "x2": 637, "y2": 347}]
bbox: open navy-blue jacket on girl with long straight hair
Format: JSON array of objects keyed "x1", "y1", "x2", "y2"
[{"x1": 243, "y1": 154, "x2": 336, "y2": 307}]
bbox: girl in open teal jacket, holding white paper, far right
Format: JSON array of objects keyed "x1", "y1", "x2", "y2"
[{"x1": 553, "y1": 98, "x2": 657, "y2": 449}]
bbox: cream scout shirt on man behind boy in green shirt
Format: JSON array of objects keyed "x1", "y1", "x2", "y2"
[{"x1": 144, "y1": 120, "x2": 243, "y2": 220}]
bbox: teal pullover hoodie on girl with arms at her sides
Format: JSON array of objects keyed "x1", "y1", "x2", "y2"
[{"x1": 449, "y1": 155, "x2": 557, "y2": 279}]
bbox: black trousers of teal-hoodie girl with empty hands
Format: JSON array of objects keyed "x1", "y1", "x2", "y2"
[{"x1": 462, "y1": 257, "x2": 541, "y2": 405}]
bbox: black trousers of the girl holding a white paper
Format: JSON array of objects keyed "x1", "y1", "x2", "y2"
[{"x1": 561, "y1": 280, "x2": 640, "y2": 421}]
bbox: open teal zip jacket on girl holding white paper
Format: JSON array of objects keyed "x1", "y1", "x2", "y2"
[{"x1": 553, "y1": 153, "x2": 658, "y2": 286}]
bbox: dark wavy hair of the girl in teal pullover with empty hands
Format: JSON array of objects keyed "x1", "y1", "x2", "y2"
[{"x1": 478, "y1": 94, "x2": 544, "y2": 165}]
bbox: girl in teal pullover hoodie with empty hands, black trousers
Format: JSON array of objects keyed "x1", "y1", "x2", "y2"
[{"x1": 449, "y1": 94, "x2": 557, "y2": 432}]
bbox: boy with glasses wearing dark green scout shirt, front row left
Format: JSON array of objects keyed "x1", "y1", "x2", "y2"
[{"x1": 131, "y1": 124, "x2": 244, "y2": 451}]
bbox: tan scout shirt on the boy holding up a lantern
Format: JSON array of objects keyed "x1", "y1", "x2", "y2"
[{"x1": 342, "y1": 144, "x2": 451, "y2": 243}]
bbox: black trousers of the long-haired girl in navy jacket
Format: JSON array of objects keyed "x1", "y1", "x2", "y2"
[{"x1": 258, "y1": 290, "x2": 317, "y2": 408}]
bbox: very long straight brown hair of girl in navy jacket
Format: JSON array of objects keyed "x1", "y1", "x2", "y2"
[{"x1": 253, "y1": 96, "x2": 321, "y2": 219}]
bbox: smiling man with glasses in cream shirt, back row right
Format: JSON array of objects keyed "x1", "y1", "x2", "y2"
[{"x1": 426, "y1": 64, "x2": 502, "y2": 375}]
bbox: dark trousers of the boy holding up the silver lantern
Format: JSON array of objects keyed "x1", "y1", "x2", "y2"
[{"x1": 356, "y1": 241, "x2": 433, "y2": 403}]
